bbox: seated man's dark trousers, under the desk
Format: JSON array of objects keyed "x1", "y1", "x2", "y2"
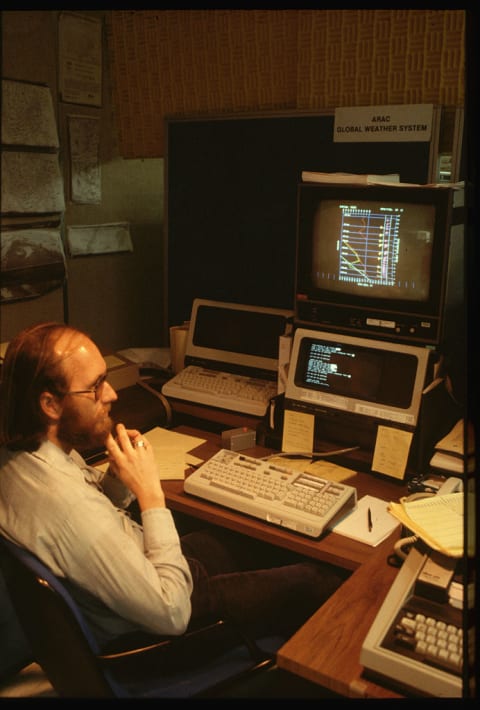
[{"x1": 181, "y1": 527, "x2": 346, "y2": 638}]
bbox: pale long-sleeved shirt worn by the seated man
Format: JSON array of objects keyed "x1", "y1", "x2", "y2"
[{"x1": 0, "y1": 441, "x2": 193, "y2": 642}]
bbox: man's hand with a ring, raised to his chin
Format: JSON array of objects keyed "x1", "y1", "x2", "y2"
[{"x1": 106, "y1": 424, "x2": 165, "y2": 510}]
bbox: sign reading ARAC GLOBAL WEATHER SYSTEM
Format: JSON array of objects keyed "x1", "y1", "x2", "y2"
[{"x1": 333, "y1": 104, "x2": 433, "y2": 143}]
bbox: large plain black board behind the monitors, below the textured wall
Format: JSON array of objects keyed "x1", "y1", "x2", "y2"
[{"x1": 165, "y1": 113, "x2": 436, "y2": 325}]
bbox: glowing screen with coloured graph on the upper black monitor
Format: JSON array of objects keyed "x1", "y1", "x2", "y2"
[{"x1": 312, "y1": 198, "x2": 435, "y2": 302}]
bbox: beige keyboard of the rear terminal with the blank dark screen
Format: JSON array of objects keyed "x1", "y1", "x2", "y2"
[{"x1": 162, "y1": 365, "x2": 277, "y2": 417}]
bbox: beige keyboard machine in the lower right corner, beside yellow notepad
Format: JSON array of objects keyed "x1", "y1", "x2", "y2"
[{"x1": 360, "y1": 547, "x2": 470, "y2": 697}]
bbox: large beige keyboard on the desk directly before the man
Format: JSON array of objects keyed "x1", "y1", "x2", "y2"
[{"x1": 184, "y1": 449, "x2": 357, "y2": 538}]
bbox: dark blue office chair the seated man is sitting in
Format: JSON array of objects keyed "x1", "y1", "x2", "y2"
[{"x1": 0, "y1": 535, "x2": 285, "y2": 698}]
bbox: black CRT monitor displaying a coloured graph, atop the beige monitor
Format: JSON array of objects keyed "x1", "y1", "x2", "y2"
[{"x1": 295, "y1": 183, "x2": 463, "y2": 345}]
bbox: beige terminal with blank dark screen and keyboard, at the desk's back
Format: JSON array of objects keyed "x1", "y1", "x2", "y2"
[{"x1": 162, "y1": 298, "x2": 293, "y2": 416}]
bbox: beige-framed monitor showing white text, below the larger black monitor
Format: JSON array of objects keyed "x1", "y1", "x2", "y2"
[{"x1": 286, "y1": 328, "x2": 430, "y2": 426}]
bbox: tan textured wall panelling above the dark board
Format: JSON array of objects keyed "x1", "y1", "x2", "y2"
[{"x1": 106, "y1": 10, "x2": 465, "y2": 158}]
